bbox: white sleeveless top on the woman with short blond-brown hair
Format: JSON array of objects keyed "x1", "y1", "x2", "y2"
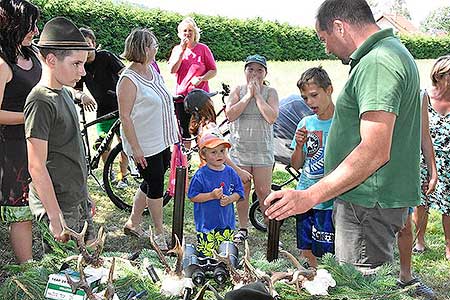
[{"x1": 117, "y1": 66, "x2": 178, "y2": 157}]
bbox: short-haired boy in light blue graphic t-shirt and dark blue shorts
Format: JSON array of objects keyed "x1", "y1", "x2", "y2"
[{"x1": 291, "y1": 66, "x2": 334, "y2": 267}]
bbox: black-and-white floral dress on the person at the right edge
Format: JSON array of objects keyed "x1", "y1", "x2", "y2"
[{"x1": 421, "y1": 99, "x2": 450, "y2": 215}]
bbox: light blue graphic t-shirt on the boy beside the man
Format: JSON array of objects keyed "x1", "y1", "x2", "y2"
[{"x1": 291, "y1": 115, "x2": 334, "y2": 210}]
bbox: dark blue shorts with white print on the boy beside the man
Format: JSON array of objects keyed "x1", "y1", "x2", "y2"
[{"x1": 296, "y1": 209, "x2": 334, "y2": 257}]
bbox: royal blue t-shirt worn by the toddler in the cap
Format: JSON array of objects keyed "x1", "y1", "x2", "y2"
[{"x1": 188, "y1": 165, "x2": 244, "y2": 233}]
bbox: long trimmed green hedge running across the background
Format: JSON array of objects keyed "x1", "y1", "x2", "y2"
[{"x1": 31, "y1": 0, "x2": 450, "y2": 61}]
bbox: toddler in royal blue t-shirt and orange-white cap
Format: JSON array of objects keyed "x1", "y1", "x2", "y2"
[{"x1": 188, "y1": 128, "x2": 244, "y2": 256}]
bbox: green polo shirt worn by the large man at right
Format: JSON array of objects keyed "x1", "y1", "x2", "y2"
[{"x1": 325, "y1": 29, "x2": 421, "y2": 208}]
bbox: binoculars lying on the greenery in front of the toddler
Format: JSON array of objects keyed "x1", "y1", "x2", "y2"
[{"x1": 183, "y1": 241, "x2": 238, "y2": 286}]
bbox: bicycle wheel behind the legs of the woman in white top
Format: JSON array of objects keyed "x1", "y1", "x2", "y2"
[{"x1": 103, "y1": 143, "x2": 172, "y2": 214}]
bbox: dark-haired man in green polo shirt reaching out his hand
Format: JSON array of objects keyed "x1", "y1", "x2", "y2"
[{"x1": 265, "y1": 0, "x2": 421, "y2": 270}]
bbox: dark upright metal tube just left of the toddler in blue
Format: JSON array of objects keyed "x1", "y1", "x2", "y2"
[{"x1": 172, "y1": 166, "x2": 187, "y2": 248}]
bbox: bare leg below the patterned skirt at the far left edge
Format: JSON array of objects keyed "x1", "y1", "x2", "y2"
[{"x1": 9, "y1": 221, "x2": 33, "y2": 264}]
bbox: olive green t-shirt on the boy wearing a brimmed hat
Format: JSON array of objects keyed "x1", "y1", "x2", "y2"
[{"x1": 24, "y1": 85, "x2": 88, "y2": 215}]
